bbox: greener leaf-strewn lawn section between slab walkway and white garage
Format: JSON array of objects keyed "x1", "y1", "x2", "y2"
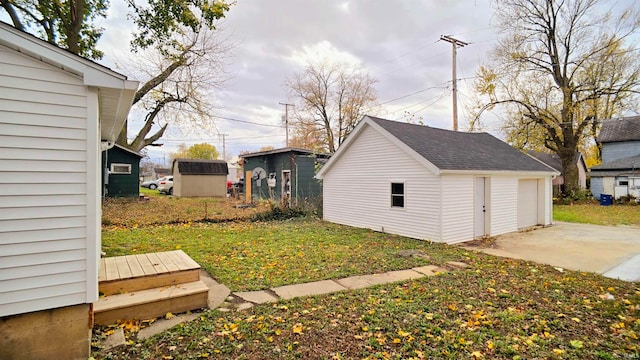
[{"x1": 102, "y1": 219, "x2": 463, "y2": 291}]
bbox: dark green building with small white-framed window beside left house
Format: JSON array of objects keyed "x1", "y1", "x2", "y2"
[{"x1": 102, "y1": 144, "x2": 143, "y2": 197}]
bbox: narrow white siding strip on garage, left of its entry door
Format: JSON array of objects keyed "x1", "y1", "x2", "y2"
[{"x1": 441, "y1": 175, "x2": 475, "y2": 244}]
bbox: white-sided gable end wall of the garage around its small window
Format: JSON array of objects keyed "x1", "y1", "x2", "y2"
[{"x1": 323, "y1": 126, "x2": 440, "y2": 241}]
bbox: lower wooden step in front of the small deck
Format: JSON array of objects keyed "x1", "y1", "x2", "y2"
[{"x1": 93, "y1": 280, "x2": 209, "y2": 325}]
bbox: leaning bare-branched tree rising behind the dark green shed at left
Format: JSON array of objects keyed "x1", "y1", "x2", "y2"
[{"x1": 118, "y1": 28, "x2": 233, "y2": 151}]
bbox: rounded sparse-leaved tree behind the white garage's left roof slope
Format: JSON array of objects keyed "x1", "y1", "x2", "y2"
[{"x1": 285, "y1": 62, "x2": 377, "y2": 153}]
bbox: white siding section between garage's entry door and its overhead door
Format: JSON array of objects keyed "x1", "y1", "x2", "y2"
[{"x1": 487, "y1": 176, "x2": 518, "y2": 236}]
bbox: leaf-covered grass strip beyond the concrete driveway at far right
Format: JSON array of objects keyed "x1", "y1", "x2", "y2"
[{"x1": 553, "y1": 203, "x2": 640, "y2": 226}]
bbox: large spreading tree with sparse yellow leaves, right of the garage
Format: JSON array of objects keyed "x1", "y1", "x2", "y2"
[{"x1": 472, "y1": 0, "x2": 640, "y2": 191}]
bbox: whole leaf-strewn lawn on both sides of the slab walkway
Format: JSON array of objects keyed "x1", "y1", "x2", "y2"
[{"x1": 93, "y1": 206, "x2": 640, "y2": 359}]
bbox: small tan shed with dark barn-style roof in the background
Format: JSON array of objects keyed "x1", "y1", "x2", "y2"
[{"x1": 173, "y1": 159, "x2": 229, "y2": 197}]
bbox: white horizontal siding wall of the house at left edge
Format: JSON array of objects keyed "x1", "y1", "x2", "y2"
[{"x1": 0, "y1": 46, "x2": 90, "y2": 316}]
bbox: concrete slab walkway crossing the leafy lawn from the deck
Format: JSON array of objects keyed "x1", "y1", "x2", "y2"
[{"x1": 97, "y1": 261, "x2": 468, "y2": 349}]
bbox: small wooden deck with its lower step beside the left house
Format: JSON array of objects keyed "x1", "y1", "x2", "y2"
[{"x1": 94, "y1": 250, "x2": 209, "y2": 324}]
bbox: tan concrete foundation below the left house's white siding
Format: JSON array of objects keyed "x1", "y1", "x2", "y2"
[{"x1": 0, "y1": 304, "x2": 92, "y2": 360}]
